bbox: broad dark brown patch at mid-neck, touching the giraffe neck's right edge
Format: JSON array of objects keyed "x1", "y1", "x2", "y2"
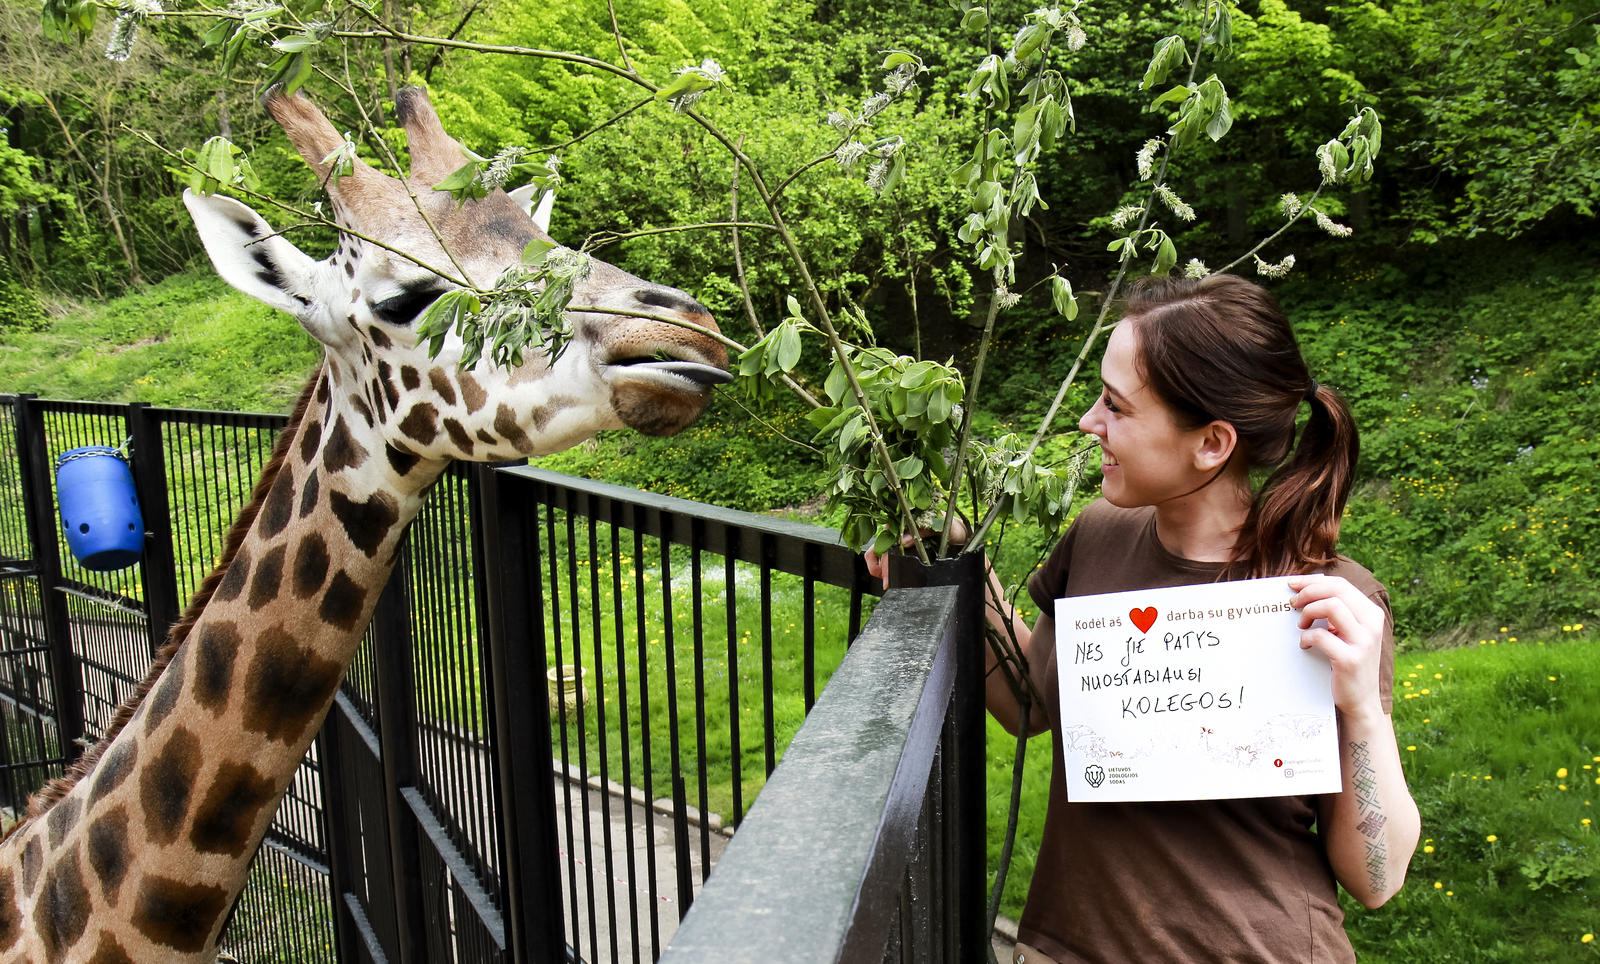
[{"x1": 243, "y1": 626, "x2": 344, "y2": 745}]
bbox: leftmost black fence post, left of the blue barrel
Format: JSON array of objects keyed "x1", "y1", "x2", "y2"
[{"x1": 16, "y1": 394, "x2": 83, "y2": 749}]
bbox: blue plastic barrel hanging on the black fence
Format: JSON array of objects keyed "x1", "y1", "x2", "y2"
[{"x1": 56, "y1": 445, "x2": 144, "y2": 572}]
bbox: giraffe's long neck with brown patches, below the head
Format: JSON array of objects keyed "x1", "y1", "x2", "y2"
[{"x1": 0, "y1": 367, "x2": 445, "y2": 961}]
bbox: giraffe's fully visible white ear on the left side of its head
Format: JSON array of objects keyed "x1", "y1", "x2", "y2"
[{"x1": 184, "y1": 191, "x2": 317, "y2": 317}]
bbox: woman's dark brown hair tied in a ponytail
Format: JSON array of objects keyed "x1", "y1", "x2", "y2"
[{"x1": 1123, "y1": 274, "x2": 1360, "y2": 576}]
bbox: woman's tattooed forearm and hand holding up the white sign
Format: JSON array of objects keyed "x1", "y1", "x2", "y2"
[{"x1": 1290, "y1": 576, "x2": 1421, "y2": 908}]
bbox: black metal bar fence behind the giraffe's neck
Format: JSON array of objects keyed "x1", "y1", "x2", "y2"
[{"x1": 0, "y1": 396, "x2": 982, "y2": 962}]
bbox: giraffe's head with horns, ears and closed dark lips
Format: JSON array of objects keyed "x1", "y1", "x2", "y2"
[{"x1": 184, "y1": 88, "x2": 730, "y2": 461}]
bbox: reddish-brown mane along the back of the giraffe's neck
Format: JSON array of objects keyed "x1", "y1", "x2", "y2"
[{"x1": 10, "y1": 365, "x2": 325, "y2": 839}]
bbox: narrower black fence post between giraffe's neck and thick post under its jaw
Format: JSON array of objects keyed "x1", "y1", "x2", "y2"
[{"x1": 373, "y1": 536, "x2": 427, "y2": 964}]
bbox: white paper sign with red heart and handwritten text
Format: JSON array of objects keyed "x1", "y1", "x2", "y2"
[{"x1": 1056, "y1": 576, "x2": 1342, "y2": 802}]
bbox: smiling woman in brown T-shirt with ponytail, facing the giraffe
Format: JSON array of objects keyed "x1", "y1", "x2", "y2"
[{"x1": 869, "y1": 275, "x2": 1419, "y2": 964}]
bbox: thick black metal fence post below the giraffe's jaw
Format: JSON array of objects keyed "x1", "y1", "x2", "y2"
[{"x1": 470, "y1": 464, "x2": 568, "y2": 962}]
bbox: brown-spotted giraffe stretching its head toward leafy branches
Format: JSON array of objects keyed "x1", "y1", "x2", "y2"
[{"x1": 0, "y1": 88, "x2": 731, "y2": 964}]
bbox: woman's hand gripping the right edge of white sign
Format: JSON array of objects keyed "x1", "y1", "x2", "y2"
[{"x1": 1290, "y1": 575, "x2": 1384, "y2": 717}]
